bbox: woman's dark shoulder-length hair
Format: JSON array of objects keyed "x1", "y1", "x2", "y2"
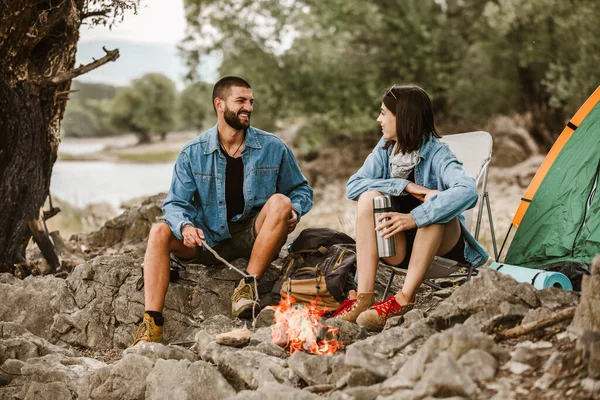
[{"x1": 381, "y1": 85, "x2": 440, "y2": 153}]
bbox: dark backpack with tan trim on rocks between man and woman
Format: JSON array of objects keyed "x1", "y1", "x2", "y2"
[{"x1": 272, "y1": 228, "x2": 356, "y2": 311}]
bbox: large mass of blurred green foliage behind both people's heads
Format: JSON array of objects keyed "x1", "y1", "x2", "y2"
[{"x1": 183, "y1": 0, "x2": 600, "y2": 152}]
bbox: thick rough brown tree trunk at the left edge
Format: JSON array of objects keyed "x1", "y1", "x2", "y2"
[{"x1": 0, "y1": 0, "x2": 85, "y2": 272}]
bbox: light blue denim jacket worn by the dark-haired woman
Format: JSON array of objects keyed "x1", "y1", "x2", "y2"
[{"x1": 346, "y1": 135, "x2": 488, "y2": 266}]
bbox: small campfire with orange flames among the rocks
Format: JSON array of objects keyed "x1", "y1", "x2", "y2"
[{"x1": 271, "y1": 296, "x2": 342, "y2": 354}]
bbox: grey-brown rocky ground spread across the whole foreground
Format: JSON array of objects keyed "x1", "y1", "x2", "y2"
[{"x1": 0, "y1": 196, "x2": 600, "y2": 400}]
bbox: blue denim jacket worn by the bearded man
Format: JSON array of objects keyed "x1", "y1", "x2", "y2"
[{"x1": 163, "y1": 125, "x2": 313, "y2": 246}]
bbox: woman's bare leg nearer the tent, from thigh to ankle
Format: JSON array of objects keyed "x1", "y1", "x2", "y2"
[{"x1": 398, "y1": 218, "x2": 461, "y2": 304}]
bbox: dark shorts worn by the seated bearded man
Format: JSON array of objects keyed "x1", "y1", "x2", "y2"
[{"x1": 173, "y1": 214, "x2": 258, "y2": 265}]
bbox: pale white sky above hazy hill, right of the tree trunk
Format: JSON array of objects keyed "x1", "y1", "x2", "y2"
[{"x1": 80, "y1": 0, "x2": 186, "y2": 45}]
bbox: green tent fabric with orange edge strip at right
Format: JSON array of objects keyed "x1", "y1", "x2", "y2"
[{"x1": 505, "y1": 88, "x2": 600, "y2": 268}]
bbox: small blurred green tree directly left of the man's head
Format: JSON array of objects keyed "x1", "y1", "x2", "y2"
[{"x1": 178, "y1": 82, "x2": 213, "y2": 130}]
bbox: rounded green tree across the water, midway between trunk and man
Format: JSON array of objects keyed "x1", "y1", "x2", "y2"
[{"x1": 111, "y1": 73, "x2": 177, "y2": 144}]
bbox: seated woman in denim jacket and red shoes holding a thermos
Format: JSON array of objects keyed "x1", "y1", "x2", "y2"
[{"x1": 334, "y1": 86, "x2": 488, "y2": 331}]
